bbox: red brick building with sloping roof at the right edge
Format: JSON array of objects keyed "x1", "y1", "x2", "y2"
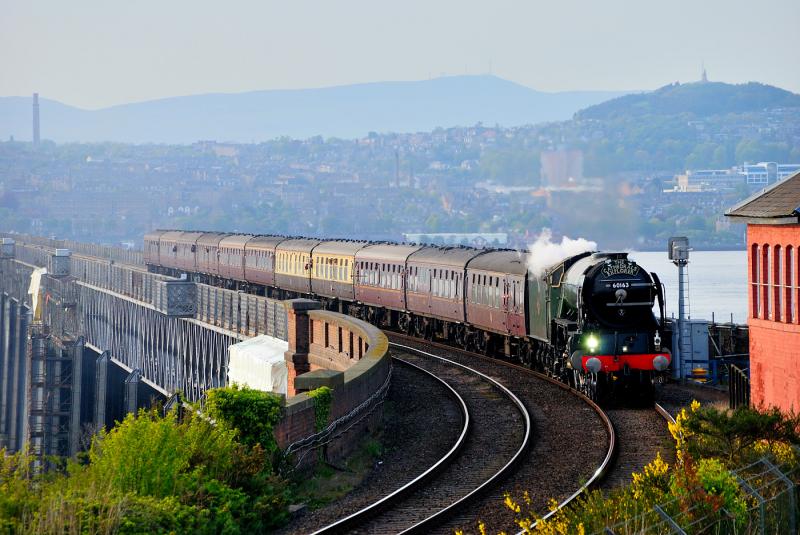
[{"x1": 720, "y1": 173, "x2": 800, "y2": 412}]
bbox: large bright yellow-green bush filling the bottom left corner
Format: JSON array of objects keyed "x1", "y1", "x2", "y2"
[{"x1": 0, "y1": 411, "x2": 291, "y2": 533}]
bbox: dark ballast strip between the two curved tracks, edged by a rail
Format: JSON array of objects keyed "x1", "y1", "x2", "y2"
[{"x1": 388, "y1": 333, "x2": 616, "y2": 533}]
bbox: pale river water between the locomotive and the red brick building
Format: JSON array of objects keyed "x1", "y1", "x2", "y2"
[{"x1": 630, "y1": 251, "x2": 747, "y2": 323}]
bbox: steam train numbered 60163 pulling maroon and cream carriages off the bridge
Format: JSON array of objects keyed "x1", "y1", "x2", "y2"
[{"x1": 144, "y1": 230, "x2": 672, "y2": 403}]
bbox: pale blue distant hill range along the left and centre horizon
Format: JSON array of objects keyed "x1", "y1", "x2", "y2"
[{"x1": 0, "y1": 76, "x2": 624, "y2": 143}]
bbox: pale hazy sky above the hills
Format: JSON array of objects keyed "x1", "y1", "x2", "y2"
[{"x1": 0, "y1": 0, "x2": 800, "y2": 108}]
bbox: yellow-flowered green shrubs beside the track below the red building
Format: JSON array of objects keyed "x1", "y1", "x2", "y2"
[{"x1": 494, "y1": 402, "x2": 800, "y2": 535}]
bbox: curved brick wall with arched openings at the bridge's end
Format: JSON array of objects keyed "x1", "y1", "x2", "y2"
[{"x1": 275, "y1": 299, "x2": 390, "y2": 462}]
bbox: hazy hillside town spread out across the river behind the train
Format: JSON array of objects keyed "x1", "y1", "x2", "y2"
[{"x1": 0, "y1": 104, "x2": 800, "y2": 249}]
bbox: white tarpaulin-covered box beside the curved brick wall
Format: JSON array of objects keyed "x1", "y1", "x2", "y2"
[{"x1": 228, "y1": 335, "x2": 289, "y2": 394}]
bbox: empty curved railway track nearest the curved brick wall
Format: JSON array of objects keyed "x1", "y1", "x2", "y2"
[{"x1": 315, "y1": 344, "x2": 531, "y2": 533}]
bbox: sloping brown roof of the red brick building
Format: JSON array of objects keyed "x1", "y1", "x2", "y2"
[{"x1": 725, "y1": 173, "x2": 800, "y2": 224}]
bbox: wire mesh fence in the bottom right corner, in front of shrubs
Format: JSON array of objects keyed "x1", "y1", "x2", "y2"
[{"x1": 597, "y1": 457, "x2": 798, "y2": 535}]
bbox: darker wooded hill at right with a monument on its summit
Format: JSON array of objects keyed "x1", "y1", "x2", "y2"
[{"x1": 576, "y1": 82, "x2": 800, "y2": 120}]
